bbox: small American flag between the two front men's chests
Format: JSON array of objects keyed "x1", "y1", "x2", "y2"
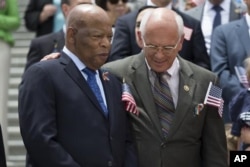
[{"x1": 122, "y1": 81, "x2": 139, "y2": 116}]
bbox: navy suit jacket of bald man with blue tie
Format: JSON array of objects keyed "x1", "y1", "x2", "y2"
[{"x1": 18, "y1": 53, "x2": 136, "y2": 167}]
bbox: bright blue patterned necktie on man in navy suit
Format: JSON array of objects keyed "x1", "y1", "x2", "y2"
[{"x1": 82, "y1": 67, "x2": 108, "y2": 117}]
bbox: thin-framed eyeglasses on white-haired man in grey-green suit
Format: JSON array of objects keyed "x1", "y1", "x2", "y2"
[{"x1": 142, "y1": 38, "x2": 180, "y2": 55}]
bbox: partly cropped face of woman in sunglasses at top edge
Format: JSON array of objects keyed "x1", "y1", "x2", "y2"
[{"x1": 107, "y1": 0, "x2": 128, "y2": 16}]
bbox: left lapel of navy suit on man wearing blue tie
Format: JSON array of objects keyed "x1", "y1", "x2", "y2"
[{"x1": 60, "y1": 52, "x2": 107, "y2": 116}]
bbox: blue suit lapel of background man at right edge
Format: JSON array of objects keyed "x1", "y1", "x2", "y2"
[{"x1": 235, "y1": 17, "x2": 250, "y2": 55}]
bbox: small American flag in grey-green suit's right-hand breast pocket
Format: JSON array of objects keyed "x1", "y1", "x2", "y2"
[{"x1": 204, "y1": 82, "x2": 224, "y2": 117}]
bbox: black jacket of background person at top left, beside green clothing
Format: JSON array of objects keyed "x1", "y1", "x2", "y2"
[{"x1": 24, "y1": 0, "x2": 54, "y2": 37}]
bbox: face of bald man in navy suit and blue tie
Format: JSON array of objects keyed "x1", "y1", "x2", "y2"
[{"x1": 67, "y1": 15, "x2": 112, "y2": 70}]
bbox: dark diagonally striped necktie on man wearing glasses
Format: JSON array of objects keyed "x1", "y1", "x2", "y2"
[{"x1": 153, "y1": 73, "x2": 175, "y2": 137}]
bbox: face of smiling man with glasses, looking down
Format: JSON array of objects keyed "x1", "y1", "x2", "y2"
[{"x1": 142, "y1": 23, "x2": 183, "y2": 72}]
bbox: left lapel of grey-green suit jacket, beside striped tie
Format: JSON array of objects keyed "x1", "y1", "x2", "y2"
[{"x1": 129, "y1": 53, "x2": 165, "y2": 136}]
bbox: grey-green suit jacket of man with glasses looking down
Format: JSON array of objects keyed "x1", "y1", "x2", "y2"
[{"x1": 103, "y1": 53, "x2": 227, "y2": 167}]
